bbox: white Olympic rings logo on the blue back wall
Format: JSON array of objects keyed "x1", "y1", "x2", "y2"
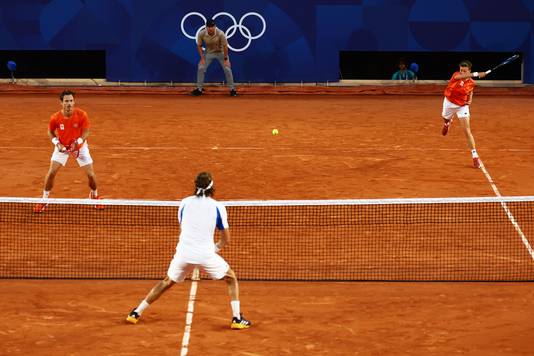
[{"x1": 180, "y1": 12, "x2": 267, "y2": 52}]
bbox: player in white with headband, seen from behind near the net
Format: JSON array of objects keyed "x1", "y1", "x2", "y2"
[{"x1": 126, "y1": 172, "x2": 251, "y2": 329}]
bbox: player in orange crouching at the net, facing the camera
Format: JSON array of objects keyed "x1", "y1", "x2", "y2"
[{"x1": 33, "y1": 90, "x2": 102, "y2": 213}]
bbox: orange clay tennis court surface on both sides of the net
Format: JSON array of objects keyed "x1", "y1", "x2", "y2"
[{"x1": 0, "y1": 87, "x2": 534, "y2": 355}]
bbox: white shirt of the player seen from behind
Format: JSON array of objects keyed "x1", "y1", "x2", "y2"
[{"x1": 176, "y1": 195, "x2": 228, "y2": 257}]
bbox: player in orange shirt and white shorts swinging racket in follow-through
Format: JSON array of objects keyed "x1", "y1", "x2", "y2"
[{"x1": 441, "y1": 60, "x2": 486, "y2": 168}]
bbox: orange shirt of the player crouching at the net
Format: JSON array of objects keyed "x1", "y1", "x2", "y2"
[{"x1": 48, "y1": 108, "x2": 89, "y2": 146}]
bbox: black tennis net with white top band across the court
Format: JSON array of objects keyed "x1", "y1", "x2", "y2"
[{"x1": 0, "y1": 197, "x2": 534, "y2": 281}]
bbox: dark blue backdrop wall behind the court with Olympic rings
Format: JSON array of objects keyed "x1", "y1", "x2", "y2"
[{"x1": 0, "y1": 0, "x2": 534, "y2": 83}]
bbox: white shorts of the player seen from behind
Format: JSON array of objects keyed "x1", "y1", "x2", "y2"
[{"x1": 167, "y1": 251, "x2": 230, "y2": 282}]
